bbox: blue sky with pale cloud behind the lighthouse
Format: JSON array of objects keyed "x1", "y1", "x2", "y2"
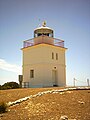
[{"x1": 0, "y1": 0, "x2": 90, "y2": 86}]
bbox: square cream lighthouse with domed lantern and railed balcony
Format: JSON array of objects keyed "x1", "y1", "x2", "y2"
[{"x1": 22, "y1": 21, "x2": 67, "y2": 88}]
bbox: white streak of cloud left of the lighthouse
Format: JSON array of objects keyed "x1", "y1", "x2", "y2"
[{"x1": 0, "y1": 59, "x2": 22, "y2": 74}]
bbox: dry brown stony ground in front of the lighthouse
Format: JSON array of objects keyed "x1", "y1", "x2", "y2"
[{"x1": 0, "y1": 88, "x2": 90, "y2": 120}]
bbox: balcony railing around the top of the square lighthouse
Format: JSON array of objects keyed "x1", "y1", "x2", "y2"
[{"x1": 23, "y1": 35, "x2": 64, "y2": 48}]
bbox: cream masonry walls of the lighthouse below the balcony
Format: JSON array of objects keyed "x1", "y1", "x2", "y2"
[{"x1": 23, "y1": 44, "x2": 66, "y2": 87}]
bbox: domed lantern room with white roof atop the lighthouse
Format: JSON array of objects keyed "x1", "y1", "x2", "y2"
[{"x1": 34, "y1": 21, "x2": 53, "y2": 37}]
